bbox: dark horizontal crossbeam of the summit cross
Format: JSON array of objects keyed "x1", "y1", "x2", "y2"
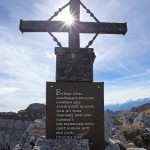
[{"x1": 20, "y1": 20, "x2": 127, "y2": 35}]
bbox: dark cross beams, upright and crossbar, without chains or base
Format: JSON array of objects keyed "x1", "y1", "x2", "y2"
[{"x1": 20, "y1": 0, "x2": 127, "y2": 51}]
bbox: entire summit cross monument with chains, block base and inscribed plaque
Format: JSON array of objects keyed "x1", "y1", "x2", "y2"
[{"x1": 20, "y1": 0, "x2": 127, "y2": 150}]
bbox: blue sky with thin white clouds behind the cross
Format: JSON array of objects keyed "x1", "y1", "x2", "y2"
[{"x1": 0, "y1": 0, "x2": 150, "y2": 111}]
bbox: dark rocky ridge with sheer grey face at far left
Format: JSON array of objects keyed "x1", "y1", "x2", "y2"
[{"x1": 0, "y1": 103, "x2": 45, "y2": 150}]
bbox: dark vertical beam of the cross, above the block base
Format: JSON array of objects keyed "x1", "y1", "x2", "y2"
[{"x1": 69, "y1": 0, "x2": 80, "y2": 51}]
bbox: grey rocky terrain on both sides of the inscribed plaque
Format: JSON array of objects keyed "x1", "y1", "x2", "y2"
[{"x1": 0, "y1": 104, "x2": 150, "y2": 150}]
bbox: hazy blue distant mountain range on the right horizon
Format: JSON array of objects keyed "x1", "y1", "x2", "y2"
[{"x1": 105, "y1": 97, "x2": 150, "y2": 111}]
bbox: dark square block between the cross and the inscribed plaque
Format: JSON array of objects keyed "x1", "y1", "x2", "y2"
[{"x1": 55, "y1": 47, "x2": 95, "y2": 82}]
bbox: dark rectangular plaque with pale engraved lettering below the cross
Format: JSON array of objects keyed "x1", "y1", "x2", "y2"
[{"x1": 46, "y1": 82, "x2": 105, "y2": 150}]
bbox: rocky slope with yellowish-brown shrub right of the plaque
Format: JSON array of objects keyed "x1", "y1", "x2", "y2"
[{"x1": 108, "y1": 104, "x2": 150, "y2": 150}]
